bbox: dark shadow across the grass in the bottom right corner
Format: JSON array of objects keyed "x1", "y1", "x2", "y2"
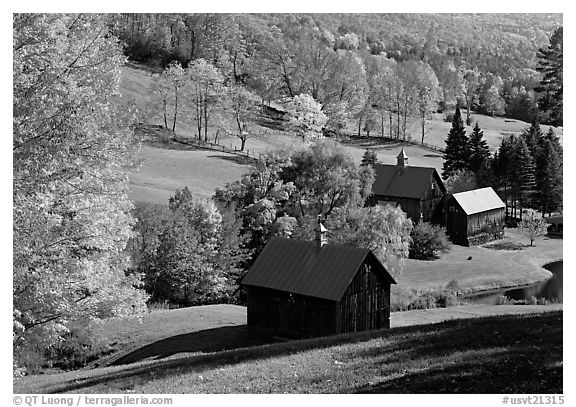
[{"x1": 350, "y1": 312, "x2": 563, "y2": 393}]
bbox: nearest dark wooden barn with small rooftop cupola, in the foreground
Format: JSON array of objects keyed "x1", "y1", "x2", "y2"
[{"x1": 241, "y1": 220, "x2": 396, "y2": 337}]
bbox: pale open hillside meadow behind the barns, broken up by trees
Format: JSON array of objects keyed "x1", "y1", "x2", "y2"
[{"x1": 121, "y1": 64, "x2": 562, "y2": 203}]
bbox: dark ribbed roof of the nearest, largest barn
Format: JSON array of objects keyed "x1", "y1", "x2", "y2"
[{"x1": 241, "y1": 237, "x2": 396, "y2": 301}]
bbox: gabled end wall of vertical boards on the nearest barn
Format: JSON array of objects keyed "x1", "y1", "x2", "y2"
[{"x1": 336, "y1": 262, "x2": 390, "y2": 333}]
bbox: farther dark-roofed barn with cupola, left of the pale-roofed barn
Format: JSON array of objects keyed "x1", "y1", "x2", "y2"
[{"x1": 371, "y1": 149, "x2": 446, "y2": 223}]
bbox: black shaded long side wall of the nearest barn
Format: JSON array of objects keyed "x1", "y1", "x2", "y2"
[{"x1": 247, "y1": 286, "x2": 336, "y2": 338}]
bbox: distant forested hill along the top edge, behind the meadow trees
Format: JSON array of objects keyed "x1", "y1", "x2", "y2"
[{"x1": 110, "y1": 14, "x2": 562, "y2": 126}]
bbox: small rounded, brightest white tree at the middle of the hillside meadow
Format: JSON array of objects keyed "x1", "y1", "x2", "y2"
[{"x1": 286, "y1": 94, "x2": 328, "y2": 141}]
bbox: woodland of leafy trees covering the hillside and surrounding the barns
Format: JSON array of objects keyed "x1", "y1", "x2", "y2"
[{"x1": 13, "y1": 14, "x2": 563, "y2": 374}]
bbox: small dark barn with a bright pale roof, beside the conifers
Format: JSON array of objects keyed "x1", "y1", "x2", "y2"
[{"x1": 446, "y1": 187, "x2": 505, "y2": 246}]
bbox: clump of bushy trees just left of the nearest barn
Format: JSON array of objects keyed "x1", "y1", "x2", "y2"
[{"x1": 133, "y1": 187, "x2": 248, "y2": 305}]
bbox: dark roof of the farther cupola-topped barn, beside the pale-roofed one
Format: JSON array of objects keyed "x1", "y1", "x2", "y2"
[{"x1": 372, "y1": 164, "x2": 446, "y2": 198}]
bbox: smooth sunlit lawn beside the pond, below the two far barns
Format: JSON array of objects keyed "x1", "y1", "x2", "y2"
[{"x1": 398, "y1": 229, "x2": 563, "y2": 291}]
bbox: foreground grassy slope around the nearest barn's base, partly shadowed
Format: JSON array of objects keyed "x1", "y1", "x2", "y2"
[{"x1": 14, "y1": 306, "x2": 563, "y2": 393}]
